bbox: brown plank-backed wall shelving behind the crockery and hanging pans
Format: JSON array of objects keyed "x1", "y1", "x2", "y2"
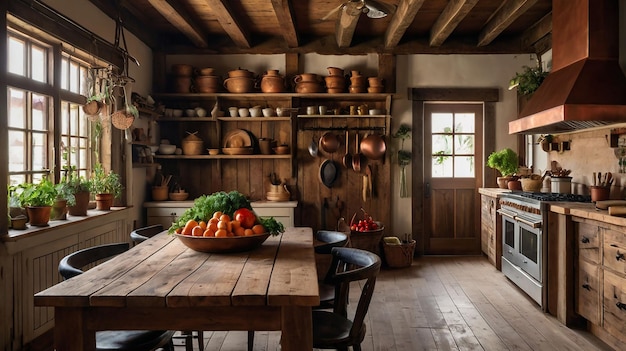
[{"x1": 147, "y1": 93, "x2": 392, "y2": 234}]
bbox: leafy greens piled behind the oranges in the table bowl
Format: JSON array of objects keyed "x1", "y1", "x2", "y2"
[{"x1": 169, "y1": 191, "x2": 252, "y2": 234}]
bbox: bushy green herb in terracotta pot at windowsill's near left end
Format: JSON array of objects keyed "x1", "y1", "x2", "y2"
[{"x1": 16, "y1": 177, "x2": 57, "y2": 226}]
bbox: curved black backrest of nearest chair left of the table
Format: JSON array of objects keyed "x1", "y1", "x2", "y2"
[{"x1": 59, "y1": 243, "x2": 130, "y2": 279}]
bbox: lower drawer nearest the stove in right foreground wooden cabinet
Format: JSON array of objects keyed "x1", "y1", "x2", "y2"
[{"x1": 574, "y1": 260, "x2": 602, "y2": 325}]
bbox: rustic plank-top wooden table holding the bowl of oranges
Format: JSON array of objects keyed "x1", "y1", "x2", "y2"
[{"x1": 35, "y1": 228, "x2": 319, "y2": 351}]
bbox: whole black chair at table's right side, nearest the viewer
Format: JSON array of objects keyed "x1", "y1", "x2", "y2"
[{"x1": 313, "y1": 247, "x2": 381, "y2": 351}]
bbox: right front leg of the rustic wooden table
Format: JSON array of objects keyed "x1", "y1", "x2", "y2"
[{"x1": 280, "y1": 306, "x2": 313, "y2": 351}]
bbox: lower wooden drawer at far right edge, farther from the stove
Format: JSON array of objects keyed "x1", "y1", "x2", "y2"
[{"x1": 603, "y1": 271, "x2": 626, "y2": 342}]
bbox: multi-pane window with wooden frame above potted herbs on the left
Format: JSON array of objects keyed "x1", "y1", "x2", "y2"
[{"x1": 7, "y1": 28, "x2": 91, "y2": 185}]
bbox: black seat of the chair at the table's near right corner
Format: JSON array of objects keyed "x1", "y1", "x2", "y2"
[{"x1": 313, "y1": 311, "x2": 365, "y2": 349}]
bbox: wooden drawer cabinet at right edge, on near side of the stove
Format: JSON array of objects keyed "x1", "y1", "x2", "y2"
[{"x1": 573, "y1": 217, "x2": 626, "y2": 348}]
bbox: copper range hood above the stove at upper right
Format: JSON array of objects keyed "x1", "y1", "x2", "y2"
[{"x1": 509, "y1": 0, "x2": 626, "y2": 134}]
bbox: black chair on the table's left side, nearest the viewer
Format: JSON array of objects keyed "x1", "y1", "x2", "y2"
[{"x1": 59, "y1": 243, "x2": 174, "y2": 351}]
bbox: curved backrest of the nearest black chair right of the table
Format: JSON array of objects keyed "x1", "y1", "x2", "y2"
[{"x1": 328, "y1": 247, "x2": 381, "y2": 339}]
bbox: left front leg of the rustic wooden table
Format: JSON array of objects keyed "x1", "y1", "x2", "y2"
[{"x1": 54, "y1": 307, "x2": 96, "y2": 351}]
